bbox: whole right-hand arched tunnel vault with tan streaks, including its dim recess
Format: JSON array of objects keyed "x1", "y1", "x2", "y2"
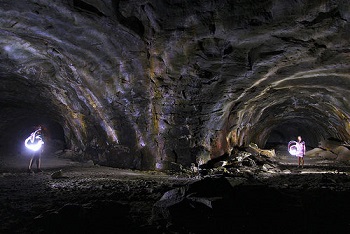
[{"x1": 223, "y1": 60, "x2": 350, "y2": 147}]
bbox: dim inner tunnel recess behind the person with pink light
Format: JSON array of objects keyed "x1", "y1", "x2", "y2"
[{"x1": 237, "y1": 95, "x2": 348, "y2": 147}]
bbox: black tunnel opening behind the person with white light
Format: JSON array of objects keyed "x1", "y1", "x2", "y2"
[{"x1": 0, "y1": 74, "x2": 66, "y2": 157}]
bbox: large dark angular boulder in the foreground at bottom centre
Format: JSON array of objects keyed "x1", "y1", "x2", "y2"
[{"x1": 151, "y1": 177, "x2": 246, "y2": 232}]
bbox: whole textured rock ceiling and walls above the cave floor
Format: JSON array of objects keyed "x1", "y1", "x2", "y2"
[{"x1": 0, "y1": 0, "x2": 350, "y2": 169}]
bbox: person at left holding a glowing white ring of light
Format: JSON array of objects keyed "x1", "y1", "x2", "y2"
[{"x1": 25, "y1": 126, "x2": 44, "y2": 173}]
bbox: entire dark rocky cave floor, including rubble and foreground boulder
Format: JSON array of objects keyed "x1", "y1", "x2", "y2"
[{"x1": 0, "y1": 154, "x2": 350, "y2": 233}]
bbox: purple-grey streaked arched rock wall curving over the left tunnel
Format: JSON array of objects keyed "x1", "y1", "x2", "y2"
[{"x1": 0, "y1": 2, "x2": 153, "y2": 169}]
